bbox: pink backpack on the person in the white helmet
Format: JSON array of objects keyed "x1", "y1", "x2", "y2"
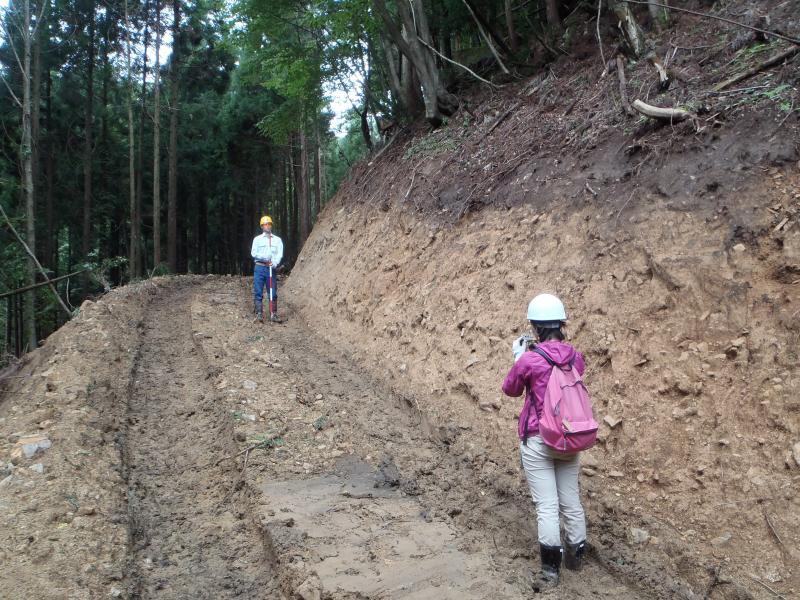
[{"x1": 533, "y1": 348, "x2": 598, "y2": 453}]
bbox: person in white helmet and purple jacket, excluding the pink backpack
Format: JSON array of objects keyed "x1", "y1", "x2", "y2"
[{"x1": 503, "y1": 294, "x2": 586, "y2": 591}]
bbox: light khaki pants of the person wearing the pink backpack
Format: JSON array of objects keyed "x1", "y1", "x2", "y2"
[{"x1": 519, "y1": 435, "x2": 586, "y2": 546}]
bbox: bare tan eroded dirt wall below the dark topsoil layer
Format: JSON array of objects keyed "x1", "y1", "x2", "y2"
[{"x1": 284, "y1": 166, "x2": 800, "y2": 597}]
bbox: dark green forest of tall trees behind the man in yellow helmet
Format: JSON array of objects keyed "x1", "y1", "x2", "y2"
[{"x1": 0, "y1": 0, "x2": 692, "y2": 354}]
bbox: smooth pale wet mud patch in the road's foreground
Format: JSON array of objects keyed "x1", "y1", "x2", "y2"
[{"x1": 262, "y1": 459, "x2": 516, "y2": 599}]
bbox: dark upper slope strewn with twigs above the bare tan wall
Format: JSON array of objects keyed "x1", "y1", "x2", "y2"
[{"x1": 352, "y1": 0, "x2": 800, "y2": 224}]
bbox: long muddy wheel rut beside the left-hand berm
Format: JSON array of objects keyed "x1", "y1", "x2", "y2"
[{"x1": 123, "y1": 282, "x2": 275, "y2": 599}]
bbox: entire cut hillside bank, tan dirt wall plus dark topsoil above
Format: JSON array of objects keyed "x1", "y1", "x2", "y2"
[{"x1": 286, "y1": 14, "x2": 800, "y2": 598}]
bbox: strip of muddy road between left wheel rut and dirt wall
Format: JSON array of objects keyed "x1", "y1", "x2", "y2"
[{"x1": 193, "y1": 280, "x2": 691, "y2": 600}]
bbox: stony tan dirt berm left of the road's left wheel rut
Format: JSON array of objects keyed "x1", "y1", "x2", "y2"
[{"x1": 0, "y1": 284, "x2": 149, "y2": 599}]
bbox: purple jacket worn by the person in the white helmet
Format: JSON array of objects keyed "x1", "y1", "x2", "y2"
[{"x1": 503, "y1": 340, "x2": 586, "y2": 439}]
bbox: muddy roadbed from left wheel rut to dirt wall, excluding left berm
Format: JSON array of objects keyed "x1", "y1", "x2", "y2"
[{"x1": 126, "y1": 278, "x2": 677, "y2": 599}]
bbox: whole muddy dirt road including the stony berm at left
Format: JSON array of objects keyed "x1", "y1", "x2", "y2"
[{"x1": 0, "y1": 277, "x2": 694, "y2": 600}]
